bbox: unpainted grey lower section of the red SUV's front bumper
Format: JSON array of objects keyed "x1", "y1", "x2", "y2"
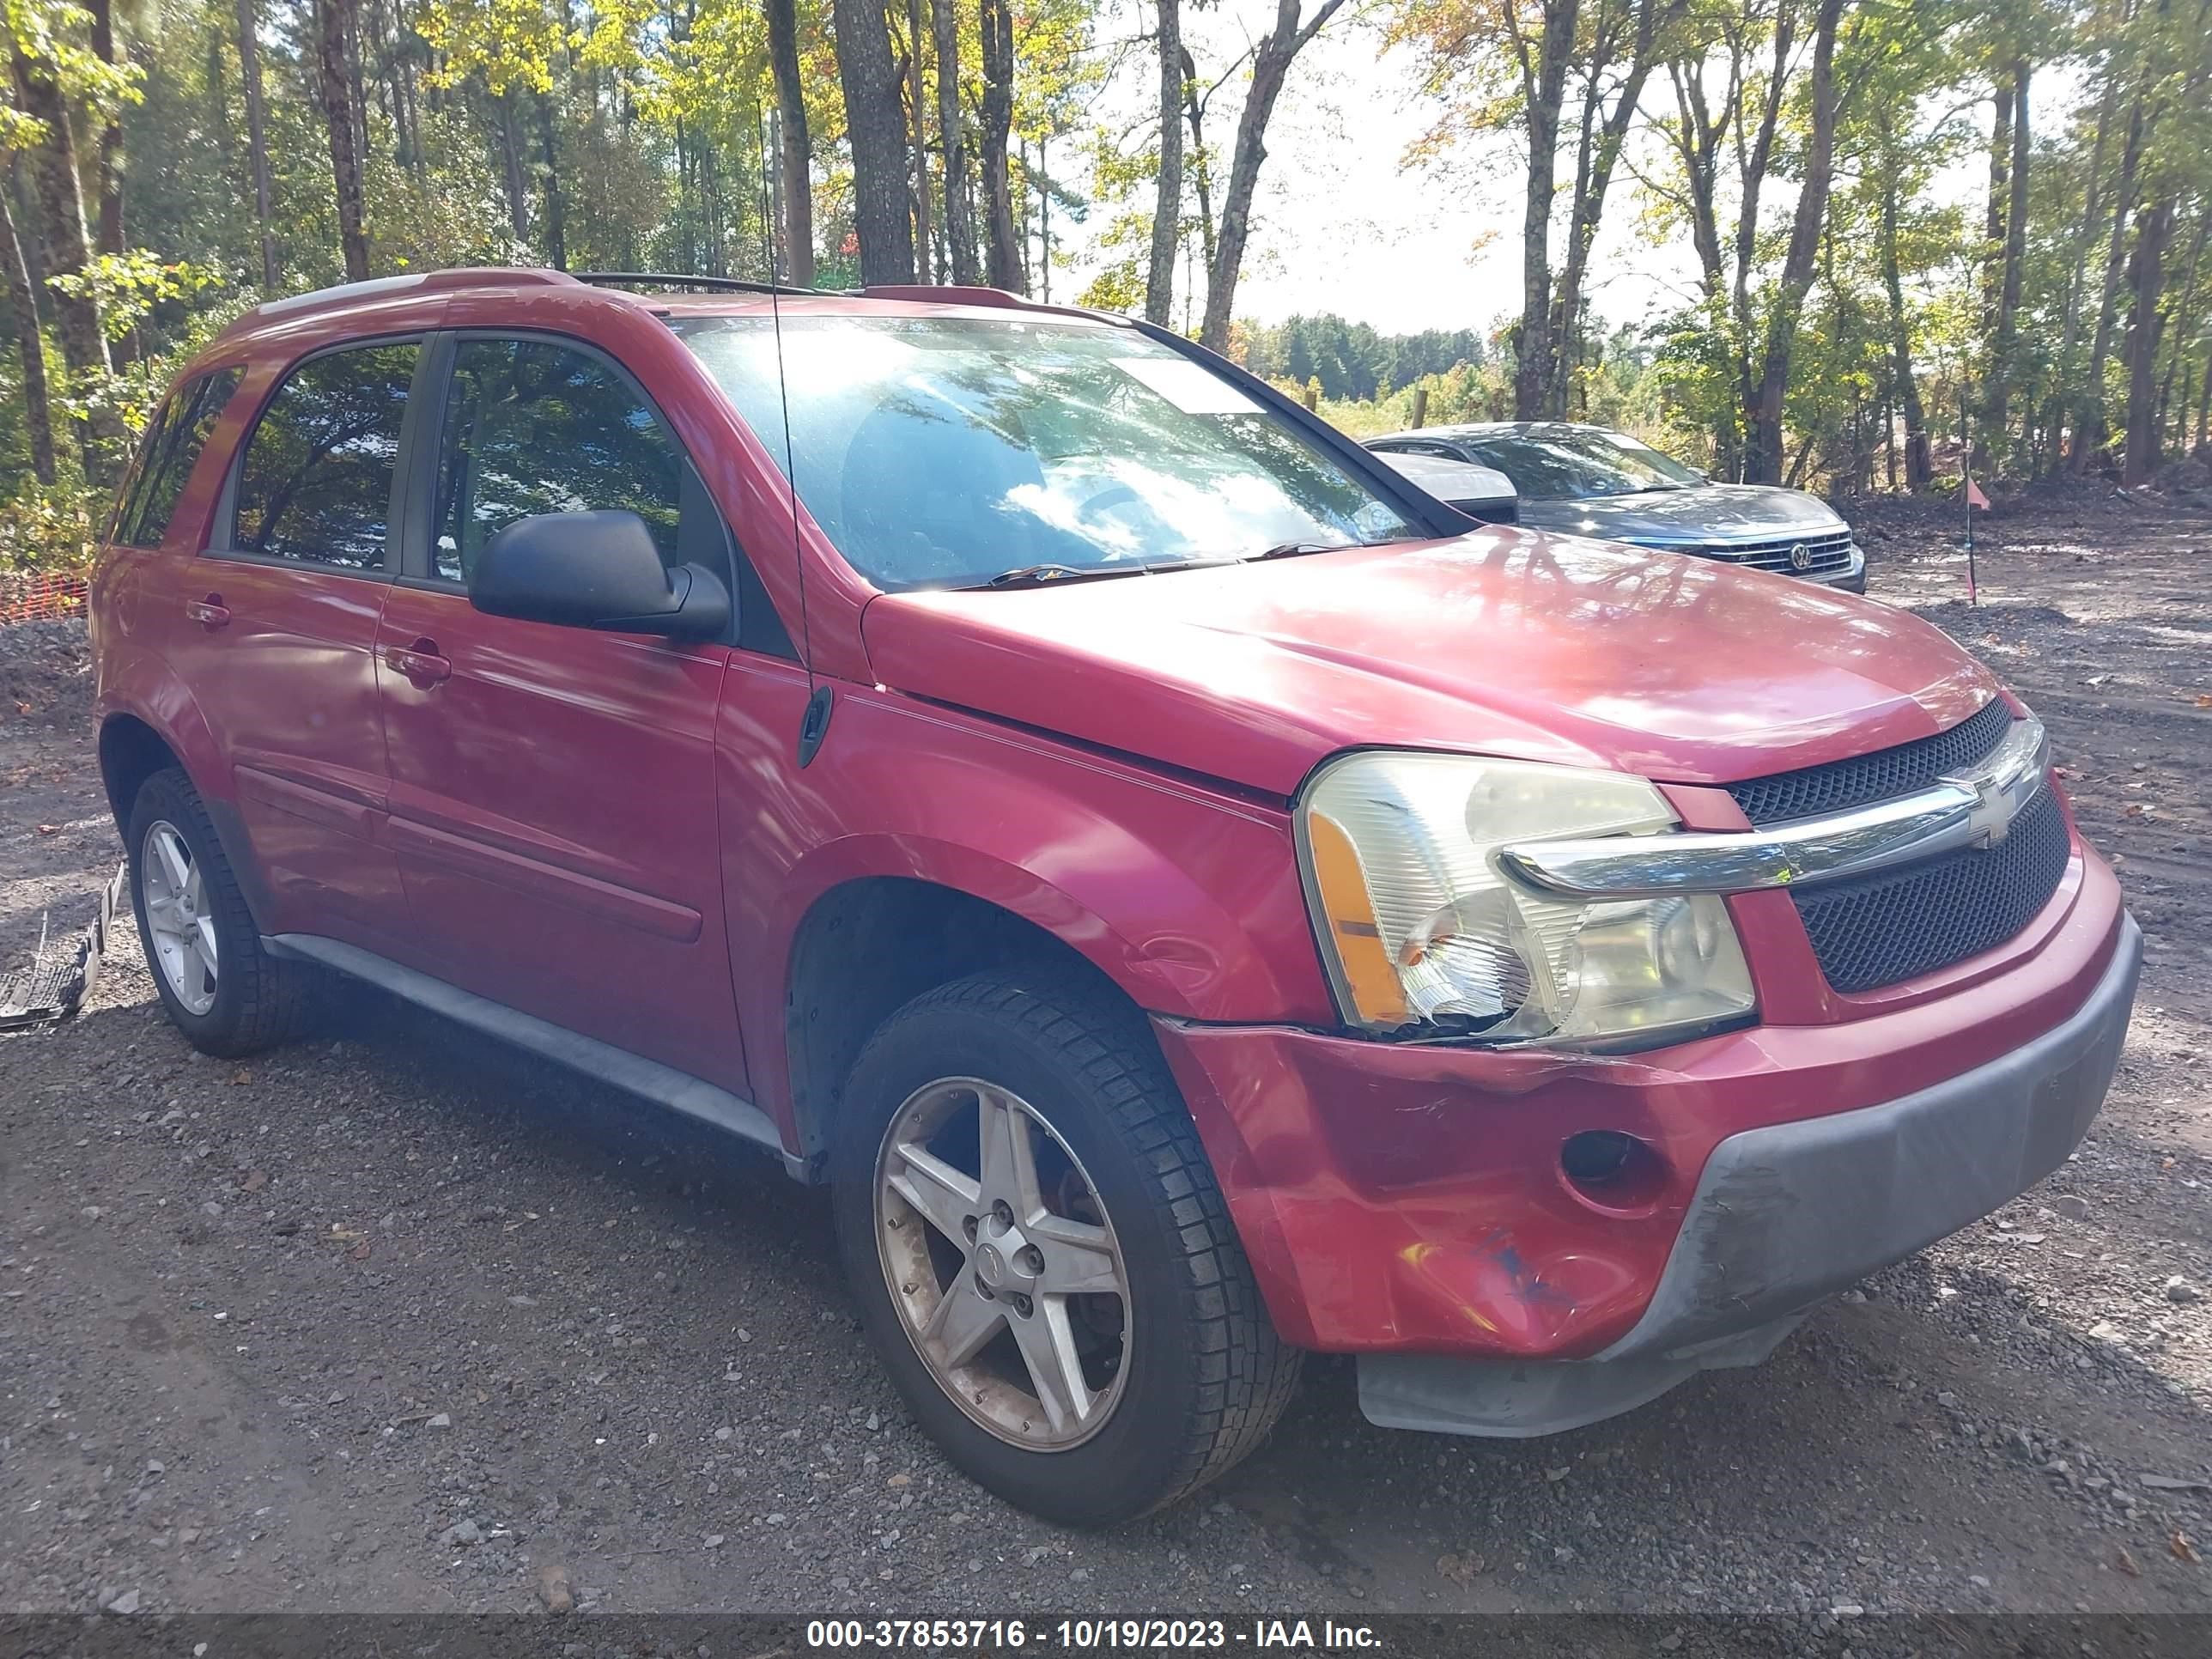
[{"x1": 1358, "y1": 918, "x2": 2143, "y2": 1437}]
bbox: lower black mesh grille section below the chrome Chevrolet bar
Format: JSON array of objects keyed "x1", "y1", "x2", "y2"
[{"x1": 1794, "y1": 787, "x2": 2070, "y2": 995}]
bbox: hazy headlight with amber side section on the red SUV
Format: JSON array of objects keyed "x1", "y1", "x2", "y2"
[{"x1": 1298, "y1": 750, "x2": 1754, "y2": 1042}]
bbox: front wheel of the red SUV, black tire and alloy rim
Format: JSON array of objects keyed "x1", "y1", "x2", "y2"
[{"x1": 832, "y1": 973, "x2": 1303, "y2": 1526}]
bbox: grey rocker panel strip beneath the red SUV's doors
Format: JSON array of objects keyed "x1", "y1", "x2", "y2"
[{"x1": 261, "y1": 933, "x2": 810, "y2": 1182}]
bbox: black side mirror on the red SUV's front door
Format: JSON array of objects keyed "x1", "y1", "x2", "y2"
[{"x1": 469, "y1": 514, "x2": 730, "y2": 639}]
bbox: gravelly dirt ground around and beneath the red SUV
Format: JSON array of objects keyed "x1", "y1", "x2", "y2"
[{"x1": 0, "y1": 487, "x2": 2212, "y2": 1617}]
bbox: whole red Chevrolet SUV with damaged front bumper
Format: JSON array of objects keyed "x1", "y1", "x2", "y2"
[{"x1": 91, "y1": 272, "x2": 2142, "y2": 1524}]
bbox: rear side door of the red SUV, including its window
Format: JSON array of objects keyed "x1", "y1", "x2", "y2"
[{"x1": 168, "y1": 338, "x2": 422, "y2": 947}]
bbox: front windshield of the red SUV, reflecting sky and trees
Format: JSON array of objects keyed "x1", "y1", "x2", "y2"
[{"x1": 675, "y1": 316, "x2": 1420, "y2": 591}]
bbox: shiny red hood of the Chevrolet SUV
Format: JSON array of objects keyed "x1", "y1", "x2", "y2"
[{"x1": 863, "y1": 531, "x2": 1996, "y2": 796}]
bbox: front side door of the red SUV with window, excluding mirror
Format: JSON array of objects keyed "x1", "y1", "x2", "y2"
[{"x1": 378, "y1": 334, "x2": 745, "y2": 1093}]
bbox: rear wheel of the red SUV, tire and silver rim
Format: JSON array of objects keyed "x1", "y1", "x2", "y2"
[{"x1": 124, "y1": 768, "x2": 319, "y2": 1060}]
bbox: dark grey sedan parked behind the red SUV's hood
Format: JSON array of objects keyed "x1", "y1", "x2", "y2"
[{"x1": 1367, "y1": 420, "x2": 1867, "y2": 592}]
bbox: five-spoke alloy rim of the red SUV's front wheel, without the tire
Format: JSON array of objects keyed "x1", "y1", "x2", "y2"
[{"x1": 876, "y1": 1078, "x2": 1130, "y2": 1451}]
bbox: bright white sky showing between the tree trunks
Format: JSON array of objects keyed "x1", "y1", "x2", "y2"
[{"x1": 1053, "y1": 0, "x2": 2048, "y2": 344}]
